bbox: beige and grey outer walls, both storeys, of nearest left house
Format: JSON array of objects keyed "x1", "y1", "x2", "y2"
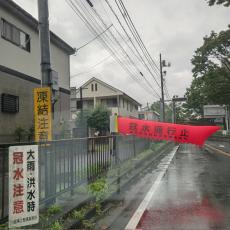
[{"x1": 0, "y1": 8, "x2": 70, "y2": 142}]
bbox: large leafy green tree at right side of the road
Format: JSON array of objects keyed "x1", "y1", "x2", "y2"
[{"x1": 185, "y1": 28, "x2": 230, "y2": 115}]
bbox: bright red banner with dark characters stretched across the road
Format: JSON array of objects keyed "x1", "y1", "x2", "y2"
[{"x1": 118, "y1": 117, "x2": 220, "y2": 146}]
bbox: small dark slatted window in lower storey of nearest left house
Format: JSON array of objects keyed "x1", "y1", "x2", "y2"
[{"x1": 1, "y1": 93, "x2": 19, "y2": 113}]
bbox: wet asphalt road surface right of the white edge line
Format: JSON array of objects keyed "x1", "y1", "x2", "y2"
[{"x1": 138, "y1": 145, "x2": 230, "y2": 230}]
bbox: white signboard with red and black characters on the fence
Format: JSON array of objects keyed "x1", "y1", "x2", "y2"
[{"x1": 9, "y1": 145, "x2": 39, "y2": 228}]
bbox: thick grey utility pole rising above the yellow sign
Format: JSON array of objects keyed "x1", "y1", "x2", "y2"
[{"x1": 38, "y1": 0, "x2": 51, "y2": 86}]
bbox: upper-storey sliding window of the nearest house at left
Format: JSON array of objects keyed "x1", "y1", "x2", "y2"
[{"x1": 1, "y1": 19, "x2": 30, "y2": 52}]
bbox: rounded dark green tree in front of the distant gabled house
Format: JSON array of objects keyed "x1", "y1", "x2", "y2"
[{"x1": 88, "y1": 105, "x2": 110, "y2": 134}]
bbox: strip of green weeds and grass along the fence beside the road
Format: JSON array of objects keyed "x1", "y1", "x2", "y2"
[{"x1": 30, "y1": 141, "x2": 170, "y2": 230}]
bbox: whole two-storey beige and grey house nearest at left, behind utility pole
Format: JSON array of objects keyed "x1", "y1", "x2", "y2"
[{"x1": 0, "y1": 0, "x2": 75, "y2": 142}]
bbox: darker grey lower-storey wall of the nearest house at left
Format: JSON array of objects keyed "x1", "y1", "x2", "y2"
[{"x1": 0, "y1": 71, "x2": 70, "y2": 143}]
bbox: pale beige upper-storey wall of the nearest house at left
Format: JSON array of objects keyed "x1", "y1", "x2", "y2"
[{"x1": 0, "y1": 8, "x2": 70, "y2": 89}]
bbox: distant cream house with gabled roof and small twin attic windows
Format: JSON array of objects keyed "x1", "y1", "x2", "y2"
[{"x1": 71, "y1": 77, "x2": 141, "y2": 118}]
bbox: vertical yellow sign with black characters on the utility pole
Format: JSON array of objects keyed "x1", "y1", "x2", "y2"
[{"x1": 34, "y1": 87, "x2": 52, "y2": 142}]
